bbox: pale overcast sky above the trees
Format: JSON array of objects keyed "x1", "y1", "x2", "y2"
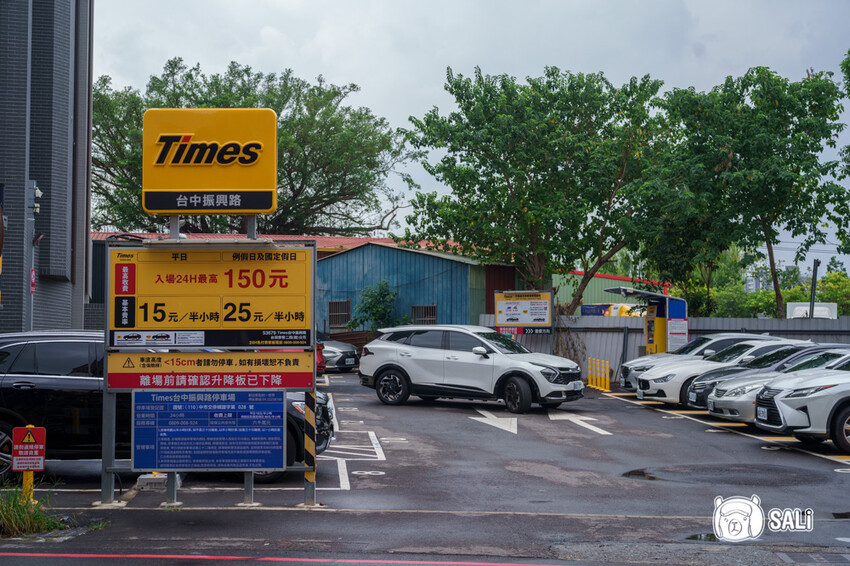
[{"x1": 94, "y1": 0, "x2": 850, "y2": 273}]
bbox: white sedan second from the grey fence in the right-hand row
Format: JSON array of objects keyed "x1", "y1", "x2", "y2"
[{"x1": 637, "y1": 340, "x2": 802, "y2": 405}]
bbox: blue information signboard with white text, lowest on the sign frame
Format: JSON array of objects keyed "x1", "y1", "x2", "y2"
[{"x1": 133, "y1": 390, "x2": 286, "y2": 471}]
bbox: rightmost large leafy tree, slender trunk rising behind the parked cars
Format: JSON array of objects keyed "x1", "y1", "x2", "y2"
[{"x1": 684, "y1": 67, "x2": 850, "y2": 318}]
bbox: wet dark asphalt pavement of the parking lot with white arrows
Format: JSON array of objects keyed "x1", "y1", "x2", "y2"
[{"x1": 0, "y1": 374, "x2": 850, "y2": 565}]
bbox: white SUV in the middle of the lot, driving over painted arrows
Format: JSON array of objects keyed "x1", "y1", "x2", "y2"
[{"x1": 359, "y1": 325, "x2": 584, "y2": 413}]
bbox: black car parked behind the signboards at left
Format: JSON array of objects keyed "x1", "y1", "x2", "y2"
[{"x1": 0, "y1": 331, "x2": 336, "y2": 481}]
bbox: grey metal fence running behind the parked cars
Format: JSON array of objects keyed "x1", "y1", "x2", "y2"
[{"x1": 480, "y1": 315, "x2": 850, "y2": 382}]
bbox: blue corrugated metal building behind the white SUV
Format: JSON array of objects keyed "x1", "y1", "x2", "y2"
[{"x1": 316, "y1": 243, "x2": 487, "y2": 330}]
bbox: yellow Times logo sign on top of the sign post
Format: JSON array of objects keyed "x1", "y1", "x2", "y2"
[{"x1": 142, "y1": 108, "x2": 277, "y2": 215}]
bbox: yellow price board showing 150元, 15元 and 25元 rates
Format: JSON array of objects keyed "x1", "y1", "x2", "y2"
[{"x1": 109, "y1": 248, "x2": 314, "y2": 348}]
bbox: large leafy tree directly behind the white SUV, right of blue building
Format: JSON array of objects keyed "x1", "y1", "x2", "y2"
[{"x1": 399, "y1": 67, "x2": 661, "y2": 314}]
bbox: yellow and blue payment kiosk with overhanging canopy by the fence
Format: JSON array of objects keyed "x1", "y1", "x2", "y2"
[{"x1": 605, "y1": 287, "x2": 688, "y2": 354}]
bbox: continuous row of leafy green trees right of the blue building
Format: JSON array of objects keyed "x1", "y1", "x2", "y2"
[{"x1": 398, "y1": 63, "x2": 850, "y2": 317}]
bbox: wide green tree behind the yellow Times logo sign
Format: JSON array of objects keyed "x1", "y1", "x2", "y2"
[{"x1": 92, "y1": 58, "x2": 417, "y2": 235}]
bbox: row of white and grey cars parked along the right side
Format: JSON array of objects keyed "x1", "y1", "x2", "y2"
[{"x1": 620, "y1": 334, "x2": 850, "y2": 454}]
